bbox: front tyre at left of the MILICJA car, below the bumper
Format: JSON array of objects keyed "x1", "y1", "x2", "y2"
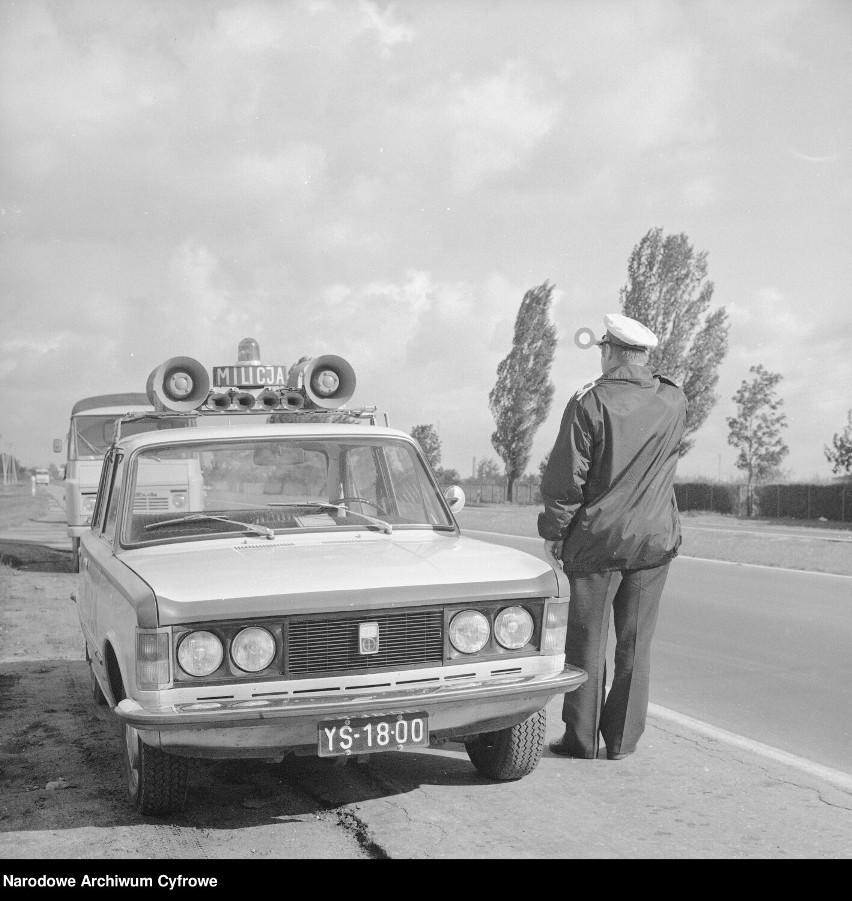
[{"x1": 124, "y1": 726, "x2": 189, "y2": 815}]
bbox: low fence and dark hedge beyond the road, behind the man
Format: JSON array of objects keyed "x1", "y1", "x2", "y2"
[{"x1": 463, "y1": 482, "x2": 852, "y2": 522}]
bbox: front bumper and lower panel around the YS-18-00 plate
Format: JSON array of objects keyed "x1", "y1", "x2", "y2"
[{"x1": 115, "y1": 665, "x2": 588, "y2": 757}]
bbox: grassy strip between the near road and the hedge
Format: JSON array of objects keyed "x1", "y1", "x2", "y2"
[{"x1": 456, "y1": 504, "x2": 852, "y2": 576}]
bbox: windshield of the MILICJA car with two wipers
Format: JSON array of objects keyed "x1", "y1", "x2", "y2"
[{"x1": 122, "y1": 436, "x2": 455, "y2": 546}]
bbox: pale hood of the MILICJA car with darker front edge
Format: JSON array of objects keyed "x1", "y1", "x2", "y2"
[{"x1": 122, "y1": 530, "x2": 566, "y2": 625}]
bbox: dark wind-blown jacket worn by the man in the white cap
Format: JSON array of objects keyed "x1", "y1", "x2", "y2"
[{"x1": 538, "y1": 365, "x2": 687, "y2": 573}]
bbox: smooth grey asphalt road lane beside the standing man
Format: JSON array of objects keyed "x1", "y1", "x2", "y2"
[{"x1": 465, "y1": 529, "x2": 852, "y2": 774}]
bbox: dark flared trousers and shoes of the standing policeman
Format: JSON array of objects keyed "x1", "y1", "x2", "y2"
[{"x1": 562, "y1": 563, "x2": 669, "y2": 758}]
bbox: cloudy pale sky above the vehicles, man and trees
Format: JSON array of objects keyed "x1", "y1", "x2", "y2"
[{"x1": 0, "y1": 0, "x2": 852, "y2": 480}]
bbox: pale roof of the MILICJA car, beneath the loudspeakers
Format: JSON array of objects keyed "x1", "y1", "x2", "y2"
[{"x1": 119, "y1": 414, "x2": 414, "y2": 451}]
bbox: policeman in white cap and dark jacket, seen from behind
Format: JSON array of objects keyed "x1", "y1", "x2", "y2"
[{"x1": 538, "y1": 313, "x2": 687, "y2": 760}]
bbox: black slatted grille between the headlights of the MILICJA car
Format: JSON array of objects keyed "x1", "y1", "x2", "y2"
[{"x1": 287, "y1": 609, "x2": 444, "y2": 676}]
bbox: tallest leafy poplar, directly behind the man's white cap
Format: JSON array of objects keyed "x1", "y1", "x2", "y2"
[{"x1": 620, "y1": 228, "x2": 728, "y2": 456}]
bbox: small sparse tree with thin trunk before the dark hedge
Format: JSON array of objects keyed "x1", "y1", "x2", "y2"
[{"x1": 728, "y1": 364, "x2": 789, "y2": 516}]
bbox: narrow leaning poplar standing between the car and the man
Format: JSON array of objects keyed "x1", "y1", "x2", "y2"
[{"x1": 488, "y1": 282, "x2": 556, "y2": 501}]
